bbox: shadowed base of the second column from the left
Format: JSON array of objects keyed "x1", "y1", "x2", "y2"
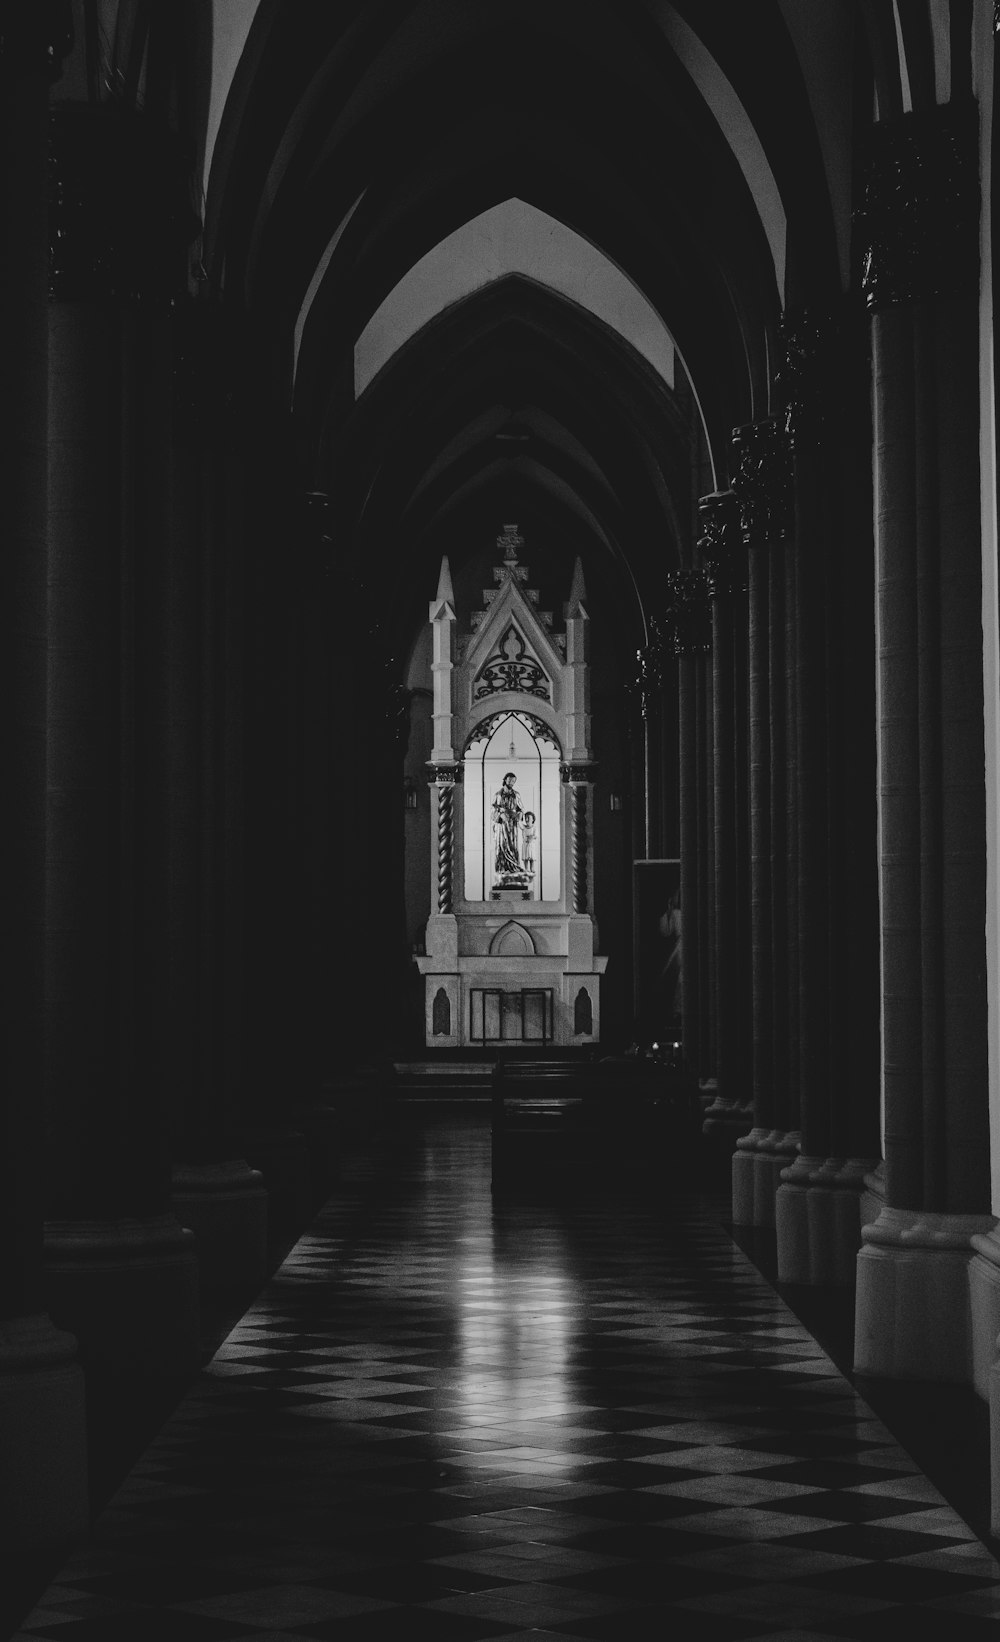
[{"x1": 44, "y1": 1215, "x2": 199, "y2": 1379}]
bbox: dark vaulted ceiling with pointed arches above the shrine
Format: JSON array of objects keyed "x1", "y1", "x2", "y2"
[{"x1": 188, "y1": 0, "x2": 932, "y2": 653}]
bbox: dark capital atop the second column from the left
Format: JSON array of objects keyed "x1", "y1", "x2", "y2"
[{"x1": 49, "y1": 103, "x2": 200, "y2": 304}]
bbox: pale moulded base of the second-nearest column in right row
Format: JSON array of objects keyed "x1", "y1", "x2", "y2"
[{"x1": 775, "y1": 1156, "x2": 872, "y2": 1287}]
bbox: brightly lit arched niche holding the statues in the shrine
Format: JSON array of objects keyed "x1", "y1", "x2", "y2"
[{"x1": 463, "y1": 711, "x2": 562, "y2": 901}]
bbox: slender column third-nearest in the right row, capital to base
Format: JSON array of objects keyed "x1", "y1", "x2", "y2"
[{"x1": 732, "y1": 419, "x2": 796, "y2": 1227}]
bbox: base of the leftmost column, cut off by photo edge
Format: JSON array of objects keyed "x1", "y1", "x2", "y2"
[{"x1": 0, "y1": 1312, "x2": 89, "y2": 1555}]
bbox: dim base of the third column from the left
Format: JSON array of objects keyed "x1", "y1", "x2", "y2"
[{"x1": 171, "y1": 1158, "x2": 268, "y2": 1299}]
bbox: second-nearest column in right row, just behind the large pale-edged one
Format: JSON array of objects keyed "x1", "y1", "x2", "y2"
[{"x1": 775, "y1": 312, "x2": 877, "y2": 1284}]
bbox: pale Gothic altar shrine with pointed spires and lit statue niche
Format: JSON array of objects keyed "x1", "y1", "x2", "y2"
[{"x1": 408, "y1": 524, "x2": 608, "y2": 1049}]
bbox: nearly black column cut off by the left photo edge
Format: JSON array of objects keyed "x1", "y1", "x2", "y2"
[{"x1": 0, "y1": 7, "x2": 87, "y2": 1557}]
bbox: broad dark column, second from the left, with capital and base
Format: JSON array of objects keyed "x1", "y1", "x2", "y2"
[{"x1": 44, "y1": 105, "x2": 199, "y2": 1378}]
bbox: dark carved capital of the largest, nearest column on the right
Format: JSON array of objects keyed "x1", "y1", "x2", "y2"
[{"x1": 856, "y1": 100, "x2": 979, "y2": 309}]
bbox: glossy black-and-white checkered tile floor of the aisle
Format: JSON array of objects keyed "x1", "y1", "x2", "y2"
[{"x1": 18, "y1": 1118, "x2": 1000, "y2": 1642}]
